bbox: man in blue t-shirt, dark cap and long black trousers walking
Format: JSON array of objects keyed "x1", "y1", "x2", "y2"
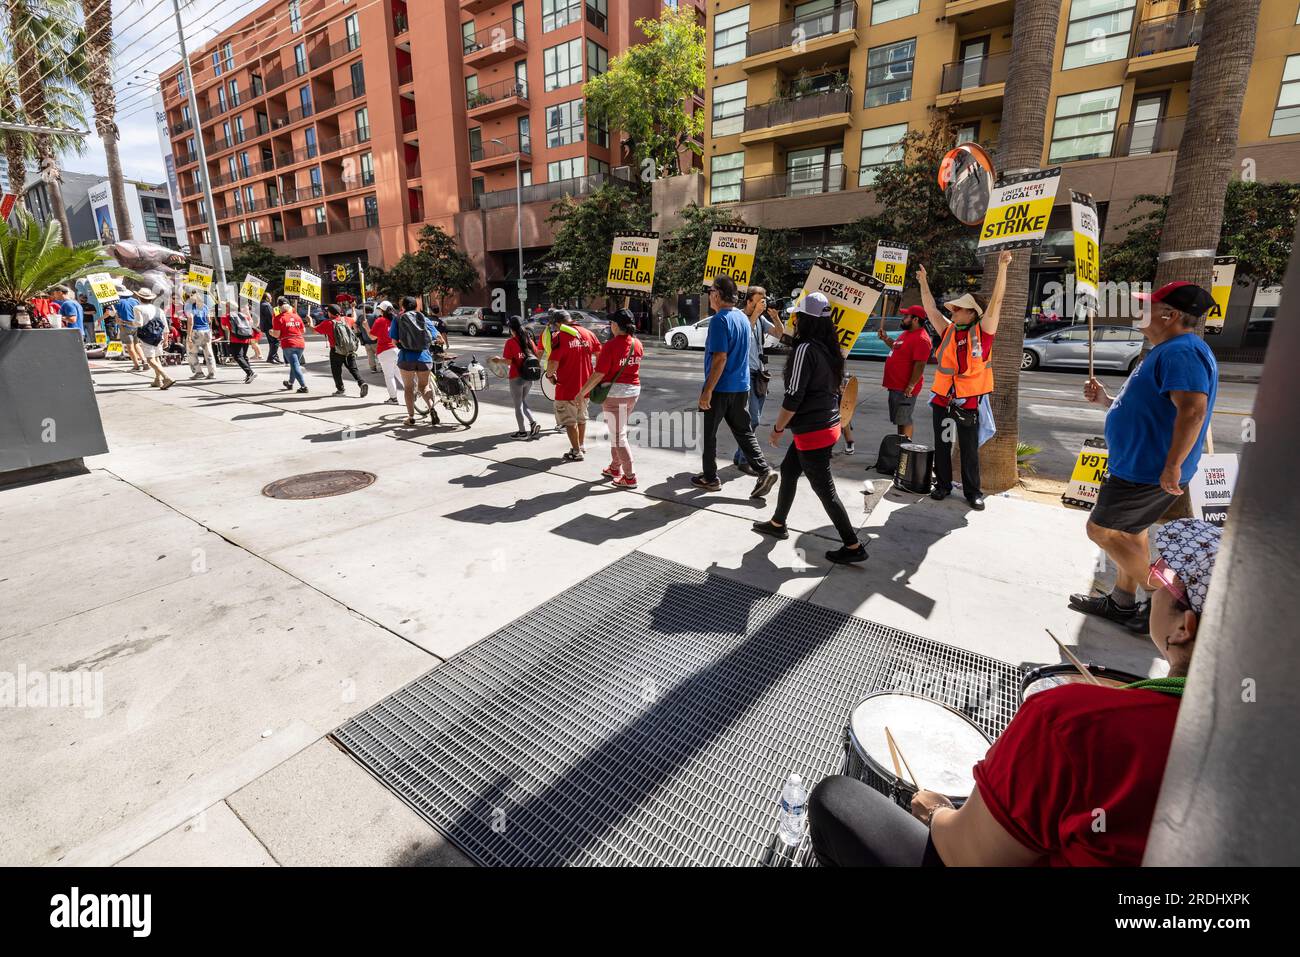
[{"x1": 690, "y1": 276, "x2": 779, "y2": 498}]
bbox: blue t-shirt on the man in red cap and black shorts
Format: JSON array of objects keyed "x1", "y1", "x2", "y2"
[{"x1": 1106, "y1": 333, "x2": 1218, "y2": 485}]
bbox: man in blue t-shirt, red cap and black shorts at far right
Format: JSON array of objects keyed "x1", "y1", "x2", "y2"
[{"x1": 1070, "y1": 282, "x2": 1218, "y2": 632}]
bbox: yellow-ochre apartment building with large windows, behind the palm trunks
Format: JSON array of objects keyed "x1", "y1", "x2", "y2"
[{"x1": 702, "y1": 0, "x2": 1300, "y2": 346}]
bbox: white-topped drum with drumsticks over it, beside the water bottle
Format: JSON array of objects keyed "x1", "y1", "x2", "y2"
[{"x1": 845, "y1": 692, "x2": 993, "y2": 807}]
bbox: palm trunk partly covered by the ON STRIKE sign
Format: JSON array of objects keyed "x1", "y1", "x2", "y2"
[{"x1": 980, "y1": 0, "x2": 1061, "y2": 492}]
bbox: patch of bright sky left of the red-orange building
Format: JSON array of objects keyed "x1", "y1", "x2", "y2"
[{"x1": 61, "y1": 0, "x2": 256, "y2": 183}]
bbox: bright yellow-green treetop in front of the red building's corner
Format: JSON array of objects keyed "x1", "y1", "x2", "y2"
[{"x1": 584, "y1": 8, "x2": 705, "y2": 177}]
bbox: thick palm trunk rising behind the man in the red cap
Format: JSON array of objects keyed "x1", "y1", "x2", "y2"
[{"x1": 1156, "y1": 0, "x2": 1260, "y2": 328}]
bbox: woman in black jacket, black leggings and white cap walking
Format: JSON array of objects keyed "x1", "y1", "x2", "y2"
[{"x1": 754, "y1": 293, "x2": 867, "y2": 564}]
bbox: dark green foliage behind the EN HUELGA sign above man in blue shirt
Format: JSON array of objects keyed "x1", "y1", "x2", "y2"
[{"x1": 655, "y1": 203, "x2": 803, "y2": 295}]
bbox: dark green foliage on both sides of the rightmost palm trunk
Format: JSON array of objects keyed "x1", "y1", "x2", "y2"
[{"x1": 1101, "y1": 179, "x2": 1300, "y2": 285}]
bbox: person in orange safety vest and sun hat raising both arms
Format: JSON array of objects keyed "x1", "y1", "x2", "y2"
[{"x1": 917, "y1": 250, "x2": 1011, "y2": 511}]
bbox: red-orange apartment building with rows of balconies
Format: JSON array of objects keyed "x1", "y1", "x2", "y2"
[{"x1": 161, "y1": 0, "x2": 702, "y2": 302}]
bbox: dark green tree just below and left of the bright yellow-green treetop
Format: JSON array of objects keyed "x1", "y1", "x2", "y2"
[{"x1": 546, "y1": 182, "x2": 658, "y2": 302}]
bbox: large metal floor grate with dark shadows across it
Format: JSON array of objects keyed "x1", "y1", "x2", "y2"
[{"x1": 334, "y1": 553, "x2": 1019, "y2": 866}]
